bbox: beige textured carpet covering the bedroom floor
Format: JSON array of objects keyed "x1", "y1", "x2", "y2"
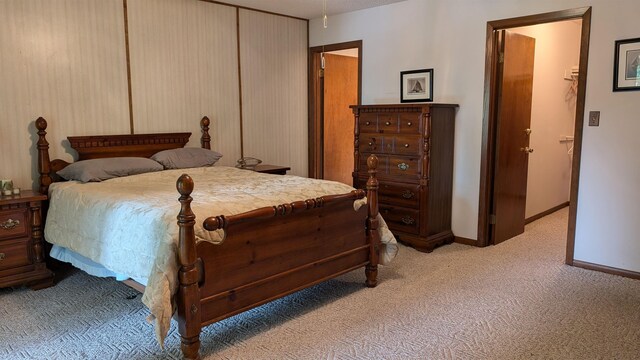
[{"x1": 0, "y1": 209, "x2": 640, "y2": 359}]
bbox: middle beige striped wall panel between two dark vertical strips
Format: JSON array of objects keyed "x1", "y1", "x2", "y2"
[{"x1": 128, "y1": 0, "x2": 240, "y2": 165}]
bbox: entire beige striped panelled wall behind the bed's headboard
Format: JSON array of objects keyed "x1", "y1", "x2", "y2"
[{"x1": 0, "y1": 0, "x2": 307, "y2": 188}]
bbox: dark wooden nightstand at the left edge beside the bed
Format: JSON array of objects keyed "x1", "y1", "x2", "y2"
[{"x1": 0, "y1": 190, "x2": 53, "y2": 290}]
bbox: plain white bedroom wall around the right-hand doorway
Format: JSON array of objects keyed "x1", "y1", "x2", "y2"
[{"x1": 309, "y1": 0, "x2": 640, "y2": 271}]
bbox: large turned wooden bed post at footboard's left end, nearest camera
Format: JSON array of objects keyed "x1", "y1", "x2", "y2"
[{"x1": 176, "y1": 174, "x2": 201, "y2": 359}]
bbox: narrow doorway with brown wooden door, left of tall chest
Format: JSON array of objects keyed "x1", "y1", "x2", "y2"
[{"x1": 309, "y1": 40, "x2": 362, "y2": 180}]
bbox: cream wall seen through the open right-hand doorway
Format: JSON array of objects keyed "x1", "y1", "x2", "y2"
[{"x1": 510, "y1": 20, "x2": 582, "y2": 218}]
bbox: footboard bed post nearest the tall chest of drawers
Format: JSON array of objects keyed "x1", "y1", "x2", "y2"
[{"x1": 365, "y1": 154, "x2": 380, "y2": 287}]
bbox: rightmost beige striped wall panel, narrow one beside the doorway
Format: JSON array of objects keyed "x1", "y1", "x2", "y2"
[{"x1": 240, "y1": 9, "x2": 308, "y2": 176}]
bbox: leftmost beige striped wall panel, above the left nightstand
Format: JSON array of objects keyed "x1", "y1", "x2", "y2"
[{"x1": 0, "y1": 0, "x2": 129, "y2": 188}]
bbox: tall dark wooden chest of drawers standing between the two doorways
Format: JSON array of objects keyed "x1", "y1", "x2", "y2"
[{"x1": 351, "y1": 104, "x2": 457, "y2": 252}]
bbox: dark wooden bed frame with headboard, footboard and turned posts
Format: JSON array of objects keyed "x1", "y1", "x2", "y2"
[{"x1": 36, "y1": 117, "x2": 380, "y2": 359}]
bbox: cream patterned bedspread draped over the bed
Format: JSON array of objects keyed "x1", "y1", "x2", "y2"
[{"x1": 45, "y1": 166, "x2": 397, "y2": 345}]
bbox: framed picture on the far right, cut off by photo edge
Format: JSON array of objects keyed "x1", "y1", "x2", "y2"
[{"x1": 613, "y1": 38, "x2": 640, "y2": 91}]
